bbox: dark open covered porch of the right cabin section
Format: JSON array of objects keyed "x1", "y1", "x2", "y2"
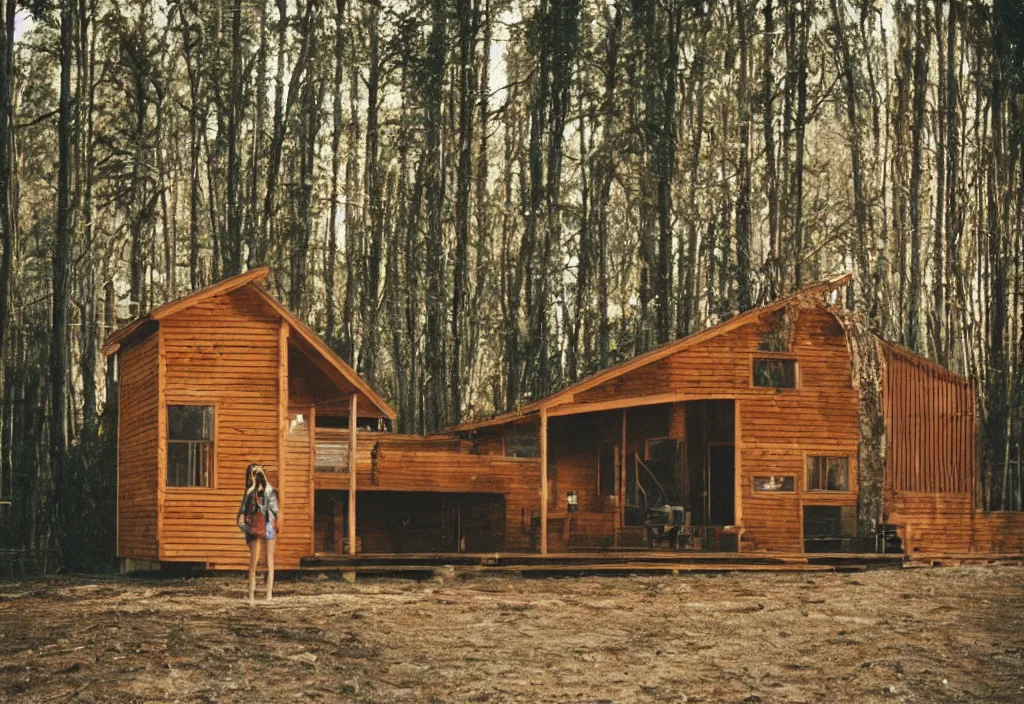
[{"x1": 463, "y1": 398, "x2": 742, "y2": 555}]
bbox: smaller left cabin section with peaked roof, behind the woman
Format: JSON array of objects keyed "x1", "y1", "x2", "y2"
[{"x1": 103, "y1": 268, "x2": 395, "y2": 569}]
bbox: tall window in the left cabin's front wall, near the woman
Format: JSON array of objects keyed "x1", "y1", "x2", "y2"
[{"x1": 167, "y1": 406, "x2": 213, "y2": 486}]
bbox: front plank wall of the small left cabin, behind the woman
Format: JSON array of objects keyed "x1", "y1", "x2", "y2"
[{"x1": 160, "y1": 290, "x2": 294, "y2": 569}]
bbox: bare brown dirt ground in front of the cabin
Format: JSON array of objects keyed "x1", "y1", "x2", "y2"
[{"x1": 0, "y1": 567, "x2": 1024, "y2": 703}]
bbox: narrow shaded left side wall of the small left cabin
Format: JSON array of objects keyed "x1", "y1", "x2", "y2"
[{"x1": 118, "y1": 335, "x2": 160, "y2": 561}]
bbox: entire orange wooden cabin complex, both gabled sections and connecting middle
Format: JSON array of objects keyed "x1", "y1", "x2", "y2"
[{"x1": 104, "y1": 269, "x2": 1024, "y2": 569}]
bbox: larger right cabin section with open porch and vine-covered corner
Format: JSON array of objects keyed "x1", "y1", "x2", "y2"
[{"x1": 453, "y1": 275, "x2": 1024, "y2": 554}]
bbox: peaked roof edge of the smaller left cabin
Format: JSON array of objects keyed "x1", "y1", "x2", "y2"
[{"x1": 102, "y1": 266, "x2": 397, "y2": 421}]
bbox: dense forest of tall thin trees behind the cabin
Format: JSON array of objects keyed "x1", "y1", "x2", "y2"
[{"x1": 0, "y1": 0, "x2": 1024, "y2": 572}]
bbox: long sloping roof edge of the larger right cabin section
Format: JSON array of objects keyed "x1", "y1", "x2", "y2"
[{"x1": 450, "y1": 273, "x2": 853, "y2": 432}]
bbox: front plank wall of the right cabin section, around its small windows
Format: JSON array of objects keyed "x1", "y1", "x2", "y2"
[{"x1": 573, "y1": 308, "x2": 859, "y2": 552}]
